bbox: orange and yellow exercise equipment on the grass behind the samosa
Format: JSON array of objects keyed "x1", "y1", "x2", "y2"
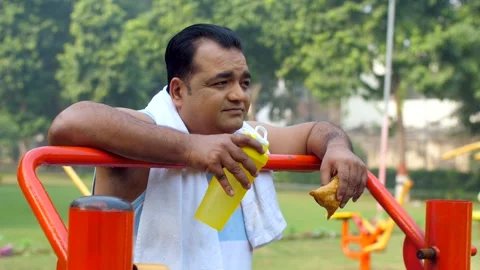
[{"x1": 332, "y1": 179, "x2": 413, "y2": 270}]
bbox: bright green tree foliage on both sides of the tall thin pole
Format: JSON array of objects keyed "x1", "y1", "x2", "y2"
[{"x1": 263, "y1": 0, "x2": 480, "y2": 132}]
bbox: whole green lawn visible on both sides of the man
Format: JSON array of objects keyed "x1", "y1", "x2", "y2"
[{"x1": 0, "y1": 174, "x2": 480, "y2": 270}]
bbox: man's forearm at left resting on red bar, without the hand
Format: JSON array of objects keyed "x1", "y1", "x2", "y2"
[{"x1": 48, "y1": 102, "x2": 188, "y2": 164}]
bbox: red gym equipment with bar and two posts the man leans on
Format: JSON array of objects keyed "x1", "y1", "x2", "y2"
[{"x1": 17, "y1": 147, "x2": 477, "y2": 270}]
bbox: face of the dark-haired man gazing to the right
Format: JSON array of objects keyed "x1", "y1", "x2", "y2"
[{"x1": 170, "y1": 40, "x2": 250, "y2": 134}]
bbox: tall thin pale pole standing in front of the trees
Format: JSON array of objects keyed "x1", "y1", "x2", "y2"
[{"x1": 377, "y1": 0, "x2": 395, "y2": 217}]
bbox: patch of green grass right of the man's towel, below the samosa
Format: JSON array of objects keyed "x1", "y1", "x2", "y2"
[{"x1": 254, "y1": 192, "x2": 424, "y2": 270}]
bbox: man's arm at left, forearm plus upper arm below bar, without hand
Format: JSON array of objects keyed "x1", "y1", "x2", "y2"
[{"x1": 48, "y1": 102, "x2": 197, "y2": 201}]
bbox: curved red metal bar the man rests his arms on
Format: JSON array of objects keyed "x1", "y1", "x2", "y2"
[{"x1": 17, "y1": 147, "x2": 476, "y2": 264}]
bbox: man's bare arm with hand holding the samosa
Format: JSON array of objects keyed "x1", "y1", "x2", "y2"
[{"x1": 250, "y1": 122, "x2": 367, "y2": 208}]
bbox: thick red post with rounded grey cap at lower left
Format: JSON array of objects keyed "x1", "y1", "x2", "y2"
[{"x1": 67, "y1": 196, "x2": 134, "y2": 270}]
